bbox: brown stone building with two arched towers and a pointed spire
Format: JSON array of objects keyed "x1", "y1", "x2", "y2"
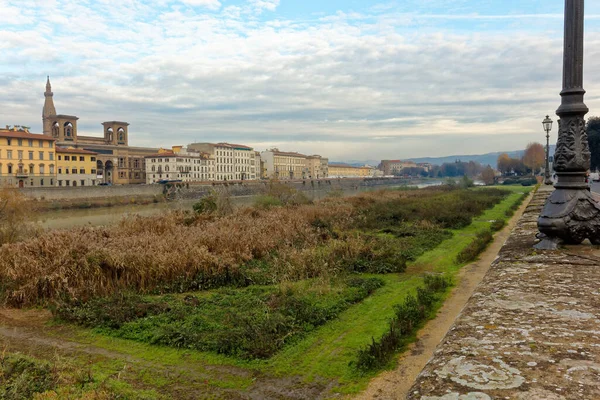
[{"x1": 42, "y1": 78, "x2": 158, "y2": 184}]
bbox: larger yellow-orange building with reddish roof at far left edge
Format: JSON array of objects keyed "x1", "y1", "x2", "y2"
[{"x1": 0, "y1": 126, "x2": 56, "y2": 187}]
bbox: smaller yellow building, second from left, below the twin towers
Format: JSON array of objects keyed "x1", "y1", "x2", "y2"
[{"x1": 56, "y1": 146, "x2": 99, "y2": 186}]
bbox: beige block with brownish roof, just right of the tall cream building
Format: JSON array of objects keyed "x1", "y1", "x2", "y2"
[{"x1": 260, "y1": 149, "x2": 310, "y2": 179}]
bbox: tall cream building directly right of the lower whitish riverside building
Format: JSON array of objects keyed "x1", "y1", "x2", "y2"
[{"x1": 188, "y1": 143, "x2": 260, "y2": 181}]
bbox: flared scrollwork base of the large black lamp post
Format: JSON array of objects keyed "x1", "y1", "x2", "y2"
[{"x1": 535, "y1": 188, "x2": 600, "y2": 249}]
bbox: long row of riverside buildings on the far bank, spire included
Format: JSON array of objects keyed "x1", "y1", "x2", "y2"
[{"x1": 0, "y1": 78, "x2": 418, "y2": 187}]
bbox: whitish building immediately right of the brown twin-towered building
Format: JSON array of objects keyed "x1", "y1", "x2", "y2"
[{"x1": 146, "y1": 146, "x2": 215, "y2": 184}]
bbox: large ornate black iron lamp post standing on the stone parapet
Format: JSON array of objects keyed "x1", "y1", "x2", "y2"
[{"x1": 536, "y1": 0, "x2": 600, "y2": 249}]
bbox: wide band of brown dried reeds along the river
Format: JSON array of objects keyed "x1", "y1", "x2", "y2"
[{"x1": 0, "y1": 189, "x2": 504, "y2": 306}]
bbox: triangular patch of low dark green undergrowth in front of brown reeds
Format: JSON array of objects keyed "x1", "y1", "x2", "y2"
[{"x1": 56, "y1": 277, "x2": 383, "y2": 359}]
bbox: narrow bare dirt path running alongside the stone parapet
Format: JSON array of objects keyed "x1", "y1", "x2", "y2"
[{"x1": 355, "y1": 190, "x2": 533, "y2": 400}]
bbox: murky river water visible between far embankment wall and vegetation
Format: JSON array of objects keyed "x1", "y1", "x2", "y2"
[{"x1": 38, "y1": 182, "x2": 441, "y2": 229}]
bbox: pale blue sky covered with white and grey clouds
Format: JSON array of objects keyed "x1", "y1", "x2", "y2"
[{"x1": 0, "y1": 0, "x2": 600, "y2": 160}]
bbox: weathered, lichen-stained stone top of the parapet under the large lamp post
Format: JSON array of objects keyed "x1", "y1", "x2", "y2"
[{"x1": 408, "y1": 187, "x2": 600, "y2": 400}]
